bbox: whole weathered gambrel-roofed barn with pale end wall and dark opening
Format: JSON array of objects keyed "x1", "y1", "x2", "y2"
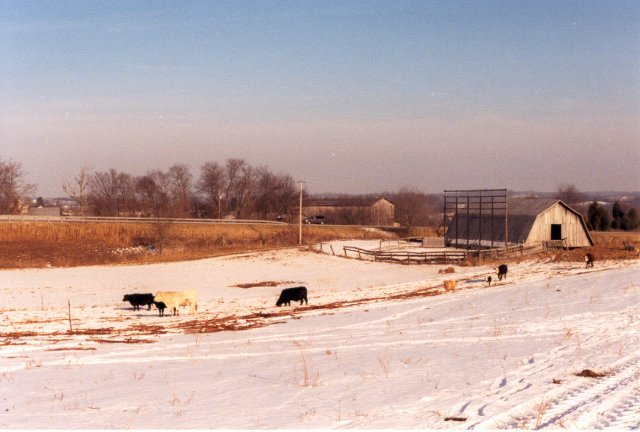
[{"x1": 446, "y1": 198, "x2": 593, "y2": 248}]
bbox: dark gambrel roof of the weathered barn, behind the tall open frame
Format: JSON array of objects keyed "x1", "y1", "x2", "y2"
[{"x1": 447, "y1": 198, "x2": 593, "y2": 244}]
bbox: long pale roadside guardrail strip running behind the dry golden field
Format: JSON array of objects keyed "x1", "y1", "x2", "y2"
[{"x1": 0, "y1": 215, "x2": 289, "y2": 226}]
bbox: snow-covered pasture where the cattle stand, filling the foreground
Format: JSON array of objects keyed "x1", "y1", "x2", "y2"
[{"x1": 0, "y1": 241, "x2": 640, "y2": 429}]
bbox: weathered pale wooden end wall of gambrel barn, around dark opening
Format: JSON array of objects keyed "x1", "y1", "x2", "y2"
[{"x1": 525, "y1": 204, "x2": 591, "y2": 247}]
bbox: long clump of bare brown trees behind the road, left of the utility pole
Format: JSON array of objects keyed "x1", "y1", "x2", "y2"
[{"x1": 63, "y1": 159, "x2": 297, "y2": 219}]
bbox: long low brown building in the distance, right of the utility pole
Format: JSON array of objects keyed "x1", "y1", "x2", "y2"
[{"x1": 296, "y1": 198, "x2": 395, "y2": 226}]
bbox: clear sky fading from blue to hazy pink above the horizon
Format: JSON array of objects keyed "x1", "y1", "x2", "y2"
[{"x1": 0, "y1": 0, "x2": 640, "y2": 196}]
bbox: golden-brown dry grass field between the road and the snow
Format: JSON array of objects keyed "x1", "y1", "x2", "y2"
[{"x1": 0, "y1": 222, "x2": 389, "y2": 268}]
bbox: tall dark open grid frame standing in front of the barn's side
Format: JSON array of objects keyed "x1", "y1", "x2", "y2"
[{"x1": 443, "y1": 189, "x2": 509, "y2": 249}]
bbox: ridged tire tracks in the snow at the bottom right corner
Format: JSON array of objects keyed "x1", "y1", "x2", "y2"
[{"x1": 472, "y1": 351, "x2": 640, "y2": 429}]
